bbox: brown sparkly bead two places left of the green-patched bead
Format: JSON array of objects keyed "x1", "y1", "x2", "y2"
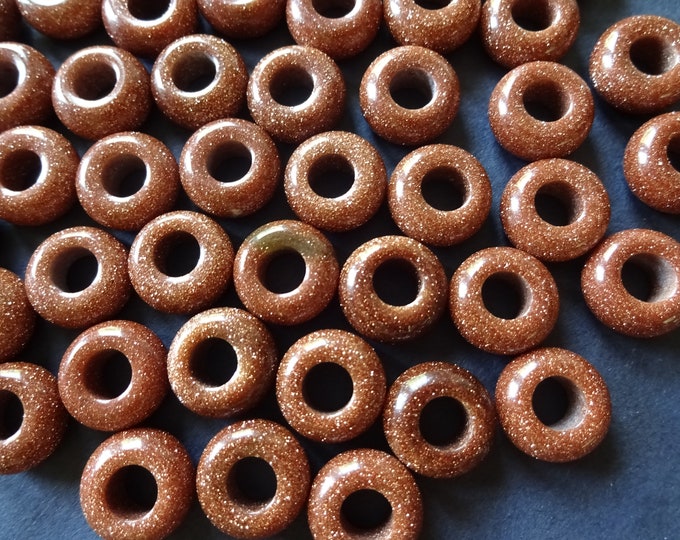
[{"x1": 26, "y1": 227, "x2": 130, "y2": 328}]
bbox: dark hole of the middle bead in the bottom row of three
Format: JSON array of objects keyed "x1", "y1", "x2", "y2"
[{"x1": 227, "y1": 456, "x2": 277, "y2": 507}]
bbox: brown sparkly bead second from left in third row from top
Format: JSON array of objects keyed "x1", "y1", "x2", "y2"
[{"x1": 76, "y1": 131, "x2": 179, "y2": 231}]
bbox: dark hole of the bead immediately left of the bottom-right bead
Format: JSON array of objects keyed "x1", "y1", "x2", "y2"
[{"x1": 419, "y1": 396, "x2": 467, "y2": 447}]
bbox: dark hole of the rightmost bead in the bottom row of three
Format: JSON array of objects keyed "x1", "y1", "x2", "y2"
[{"x1": 340, "y1": 489, "x2": 392, "y2": 538}]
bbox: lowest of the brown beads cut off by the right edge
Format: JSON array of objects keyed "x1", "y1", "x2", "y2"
[{"x1": 581, "y1": 229, "x2": 680, "y2": 337}]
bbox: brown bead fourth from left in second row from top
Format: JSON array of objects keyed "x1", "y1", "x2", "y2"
[{"x1": 247, "y1": 45, "x2": 346, "y2": 144}]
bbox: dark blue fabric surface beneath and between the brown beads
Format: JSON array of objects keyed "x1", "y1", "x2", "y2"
[{"x1": 0, "y1": 0, "x2": 680, "y2": 539}]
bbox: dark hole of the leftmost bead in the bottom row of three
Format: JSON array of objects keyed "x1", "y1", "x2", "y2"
[{"x1": 105, "y1": 465, "x2": 158, "y2": 520}]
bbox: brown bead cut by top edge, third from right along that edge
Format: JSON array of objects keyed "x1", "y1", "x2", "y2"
[{"x1": 286, "y1": 0, "x2": 383, "y2": 60}]
